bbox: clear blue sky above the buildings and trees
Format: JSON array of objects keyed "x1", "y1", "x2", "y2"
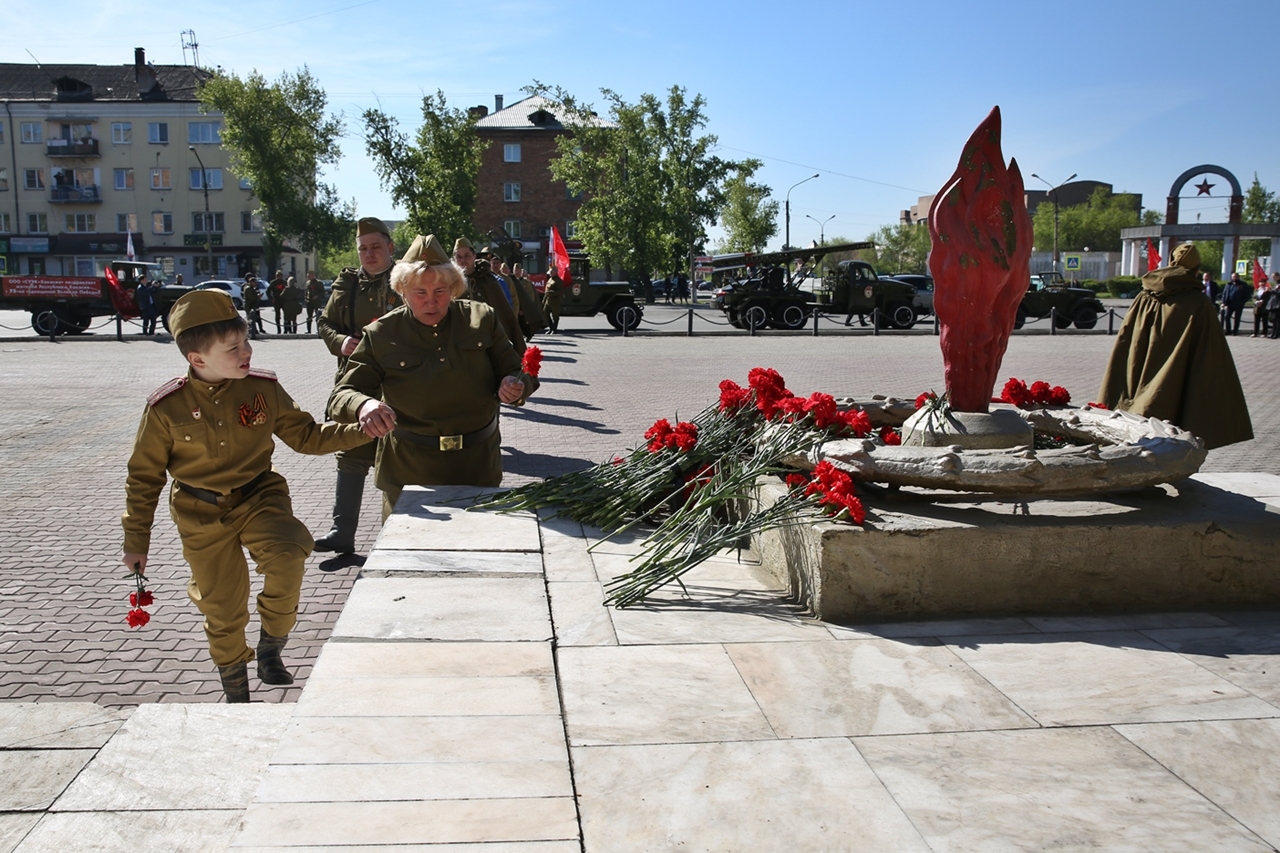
[{"x1": 0, "y1": 0, "x2": 1280, "y2": 246}]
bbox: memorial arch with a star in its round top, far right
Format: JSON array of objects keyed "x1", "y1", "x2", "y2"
[{"x1": 1120, "y1": 164, "x2": 1280, "y2": 278}]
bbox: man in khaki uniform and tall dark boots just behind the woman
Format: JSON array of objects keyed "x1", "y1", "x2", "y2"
[{"x1": 316, "y1": 216, "x2": 401, "y2": 553}]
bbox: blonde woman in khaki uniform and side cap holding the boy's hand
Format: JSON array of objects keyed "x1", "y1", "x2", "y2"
[{"x1": 329, "y1": 230, "x2": 538, "y2": 519}]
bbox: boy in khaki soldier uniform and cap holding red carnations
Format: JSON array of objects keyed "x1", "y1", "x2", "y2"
[{"x1": 122, "y1": 289, "x2": 370, "y2": 702}]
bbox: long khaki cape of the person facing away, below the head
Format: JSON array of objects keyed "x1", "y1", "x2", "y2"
[{"x1": 1098, "y1": 266, "x2": 1253, "y2": 450}]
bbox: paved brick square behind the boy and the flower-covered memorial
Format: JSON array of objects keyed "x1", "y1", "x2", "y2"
[{"x1": 0, "y1": 306, "x2": 1280, "y2": 707}]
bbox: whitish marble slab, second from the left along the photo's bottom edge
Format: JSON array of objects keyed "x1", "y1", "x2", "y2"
[{"x1": 14, "y1": 808, "x2": 242, "y2": 853}]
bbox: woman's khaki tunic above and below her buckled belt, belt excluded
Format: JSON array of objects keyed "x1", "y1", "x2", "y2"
[{"x1": 329, "y1": 300, "x2": 538, "y2": 506}]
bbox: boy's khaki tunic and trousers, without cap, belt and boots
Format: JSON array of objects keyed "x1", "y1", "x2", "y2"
[{"x1": 122, "y1": 370, "x2": 370, "y2": 666}]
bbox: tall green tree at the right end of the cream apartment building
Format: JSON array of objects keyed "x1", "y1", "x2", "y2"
[{"x1": 198, "y1": 65, "x2": 355, "y2": 269}]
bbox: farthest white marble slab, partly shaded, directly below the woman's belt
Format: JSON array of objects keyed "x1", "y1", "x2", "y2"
[{"x1": 375, "y1": 485, "x2": 541, "y2": 552}]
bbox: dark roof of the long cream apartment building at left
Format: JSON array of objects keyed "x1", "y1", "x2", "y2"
[{"x1": 0, "y1": 63, "x2": 211, "y2": 104}]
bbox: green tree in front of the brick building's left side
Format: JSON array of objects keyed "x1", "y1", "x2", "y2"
[{"x1": 361, "y1": 91, "x2": 489, "y2": 243}]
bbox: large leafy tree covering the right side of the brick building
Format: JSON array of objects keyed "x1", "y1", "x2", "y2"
[{"x1": 525, "y1": 82, "x2": 742, "y2": 278}]
